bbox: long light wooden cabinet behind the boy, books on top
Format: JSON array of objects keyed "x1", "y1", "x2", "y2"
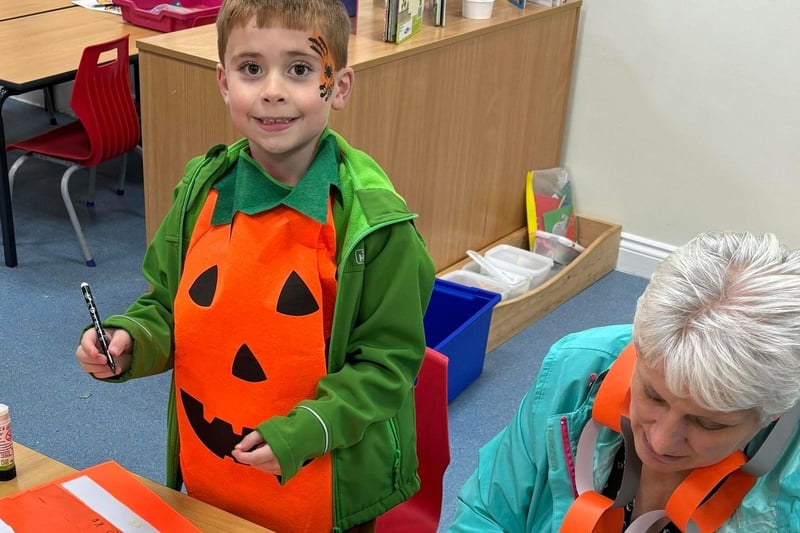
[{"x1": 134, "y1": 0, "x2": 581, "y2": 270}]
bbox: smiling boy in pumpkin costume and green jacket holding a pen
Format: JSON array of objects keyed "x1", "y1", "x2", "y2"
[{"x1": 76, "y1": 0, "x2": 434, "y2": 533}]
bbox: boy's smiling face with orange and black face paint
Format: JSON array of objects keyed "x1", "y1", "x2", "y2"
[{"x1": 217, "y1": 20, "x2": 353, "y2": 185}]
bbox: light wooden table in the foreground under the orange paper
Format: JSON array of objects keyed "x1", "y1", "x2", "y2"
[{"x1": 0, "y1": 442, "x2": 270, "y2": 533}]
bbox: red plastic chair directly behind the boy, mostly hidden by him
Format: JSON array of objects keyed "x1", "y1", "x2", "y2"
[{"x1": 375, "y1": 348, "x2": 450, "y2": 533}]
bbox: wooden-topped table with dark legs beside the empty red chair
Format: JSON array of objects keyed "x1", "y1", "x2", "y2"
[{"x1": 0, "y1": 8, "x2": 158, "y2": 267}]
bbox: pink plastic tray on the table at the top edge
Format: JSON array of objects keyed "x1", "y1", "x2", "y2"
[{"x1": 114, "y1": 0, "x2": 222, "y2": 32}]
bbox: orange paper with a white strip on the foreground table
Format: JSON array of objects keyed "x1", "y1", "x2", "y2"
[{"x1": 0, "y1": 461, "x2": 200, "y2": 533}]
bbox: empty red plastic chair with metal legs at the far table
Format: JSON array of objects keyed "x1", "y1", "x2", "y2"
[{"x1": 6, "y1": 35, "x2": 139, "y2": 266}]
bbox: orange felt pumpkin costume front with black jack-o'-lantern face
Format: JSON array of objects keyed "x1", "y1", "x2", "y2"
[{"x1": 175, "y1": 181, "x2": 336, "y2": 533}]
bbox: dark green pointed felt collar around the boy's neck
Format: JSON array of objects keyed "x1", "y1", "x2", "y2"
[{"x1": 211, "y1": 131, "x2": 341, "y2": 226}]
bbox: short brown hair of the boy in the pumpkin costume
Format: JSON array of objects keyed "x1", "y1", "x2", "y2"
[{"x1": 217, "y1": 0, "x2": 350, "y2": 70}]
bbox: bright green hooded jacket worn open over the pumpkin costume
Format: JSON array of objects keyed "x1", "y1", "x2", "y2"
[{"x1": 104, "y1": 130, "x2": 434, "y2": 531}]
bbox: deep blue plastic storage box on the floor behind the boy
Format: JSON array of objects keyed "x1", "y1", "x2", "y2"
[{"x1": 425, "y1": 278, "x2": 500, "y2": 402}]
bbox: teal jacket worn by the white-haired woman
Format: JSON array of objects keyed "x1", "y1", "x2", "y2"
[{"x1": 448, "y1": 326, "x2": 800, "y2": 533}]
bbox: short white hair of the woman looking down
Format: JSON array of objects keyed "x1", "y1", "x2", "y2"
[{"x1": 633, "y1": 233, "x2": 800, "y2": 424}]
